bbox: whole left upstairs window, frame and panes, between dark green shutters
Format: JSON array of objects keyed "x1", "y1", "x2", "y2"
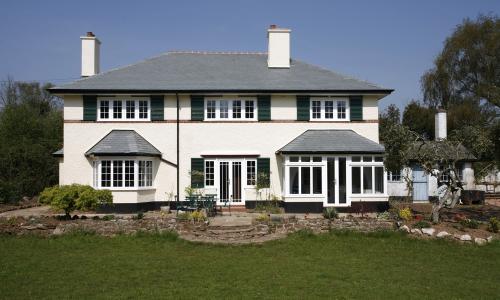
[{"x1": 97, "y1": 97, "x2": 150, "y2": 121}]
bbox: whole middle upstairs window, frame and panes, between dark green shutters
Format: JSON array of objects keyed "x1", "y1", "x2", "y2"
[{"x1": 205, "y1": 98, "x2": 257, "y2": 121}]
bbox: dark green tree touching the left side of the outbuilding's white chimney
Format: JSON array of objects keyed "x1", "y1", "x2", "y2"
[{"x1": 402, "y1": 100, "x2": 436, "y2": 140}]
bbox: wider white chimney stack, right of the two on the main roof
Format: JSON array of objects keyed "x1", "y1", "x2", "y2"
[{"x1": 267, "y1": 25, "x2": 291, "y2": 68}]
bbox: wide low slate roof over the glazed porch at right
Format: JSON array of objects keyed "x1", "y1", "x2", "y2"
[{"x1": 277, "y1": 130, "x2": 385, "y2": 154}]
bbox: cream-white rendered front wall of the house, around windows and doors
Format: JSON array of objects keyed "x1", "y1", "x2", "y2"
[{"x1": 60, "y1": 95, "x2": 378, "y2": 202}]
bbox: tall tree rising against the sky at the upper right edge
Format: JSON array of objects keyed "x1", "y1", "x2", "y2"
[{"x1": 421, "y1": 15, "x2": 500, "y2": 109}]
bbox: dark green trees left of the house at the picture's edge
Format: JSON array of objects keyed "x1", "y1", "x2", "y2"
[{"x1": 0, "y1": 78, "x2": 63, "y2": 202}]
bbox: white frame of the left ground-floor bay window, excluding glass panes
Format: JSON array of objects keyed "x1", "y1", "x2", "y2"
[{"x1": 92, "y1": 156, "x2": 156, "y2": 191}]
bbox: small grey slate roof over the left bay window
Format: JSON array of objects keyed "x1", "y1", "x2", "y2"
[{"x1": 85, "y1": 130, "x2": 161, "y2": 156}]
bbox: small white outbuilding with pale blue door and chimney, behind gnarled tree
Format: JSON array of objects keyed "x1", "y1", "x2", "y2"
[{"x1": 387, "y1": 110, "x2": 476, "y2": 203}]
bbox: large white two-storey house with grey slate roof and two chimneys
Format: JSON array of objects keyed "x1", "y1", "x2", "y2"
[{"x1": 50, "y1": 26, "x2": 392, "y2": 212}]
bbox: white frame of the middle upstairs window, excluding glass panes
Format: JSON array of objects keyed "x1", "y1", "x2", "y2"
[{"x1": 203, "y1": 97, "x2": 258, "y2": 122}]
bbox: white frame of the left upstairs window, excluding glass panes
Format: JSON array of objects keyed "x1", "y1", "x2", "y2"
[{"x1": 97, "y1": 97, "x2": 151, "y2": 122}]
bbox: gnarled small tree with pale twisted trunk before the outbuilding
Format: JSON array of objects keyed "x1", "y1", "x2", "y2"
[{"x1": 384, "y1": 124, "x2": 480, "y2": 222}]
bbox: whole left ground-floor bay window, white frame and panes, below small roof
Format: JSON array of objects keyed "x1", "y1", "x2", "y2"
[{"x1": 92, "y1": 159, "x2": 153, "y2": 189}]
